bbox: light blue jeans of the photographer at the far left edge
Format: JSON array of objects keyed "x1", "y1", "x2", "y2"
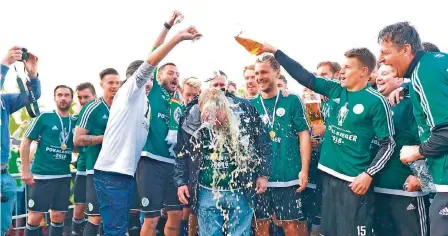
[{"x1": 0, "y1": 174, "x2": 17, "y2": 235}]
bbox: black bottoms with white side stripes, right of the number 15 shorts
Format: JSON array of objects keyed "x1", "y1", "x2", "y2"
[{"x1": 374, "y1": 193, "x2": 429, "y2": 236}]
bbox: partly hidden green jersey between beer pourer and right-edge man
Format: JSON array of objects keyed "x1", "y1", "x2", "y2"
[{"x1": 372, "y1": 97, "x2": 426, "y2": 197}]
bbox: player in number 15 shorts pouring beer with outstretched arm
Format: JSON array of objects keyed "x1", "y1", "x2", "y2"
[{"x1": 263, "y1": 44, "x2": 395, "y2": 236}]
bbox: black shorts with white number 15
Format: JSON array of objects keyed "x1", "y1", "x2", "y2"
[{"x1": 320, "y1": 172, "x2": 374, "y2": 236}]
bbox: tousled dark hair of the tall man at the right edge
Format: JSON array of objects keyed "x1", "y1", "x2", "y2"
[{"x1": 378, "y1": 22, "x2": 423, "y2": 55}]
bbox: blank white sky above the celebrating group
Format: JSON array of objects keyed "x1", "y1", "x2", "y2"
[{"x1": 0, "y1": 0, "x2": 448, "y2": 109}]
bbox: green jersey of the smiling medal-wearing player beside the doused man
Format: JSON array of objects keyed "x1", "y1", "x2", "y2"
[{"x1": 251, "y1": 92, "x2": 309, "y2": 187}]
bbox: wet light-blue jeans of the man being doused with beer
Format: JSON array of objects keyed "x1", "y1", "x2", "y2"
[{"x1": 198, "y1": 187, "x2": 253, "y2": 236}]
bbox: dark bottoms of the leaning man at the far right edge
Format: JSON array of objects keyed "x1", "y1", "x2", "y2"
[{"x1": 429, "y1": 192, "x2": 448, "y2": 236}]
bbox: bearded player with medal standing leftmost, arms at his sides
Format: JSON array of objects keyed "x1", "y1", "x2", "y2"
[{"x1": 20, "y1": 85, "x2": 76, "y2": 236}]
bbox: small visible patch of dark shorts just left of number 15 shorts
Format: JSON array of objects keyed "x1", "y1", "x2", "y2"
[{"x1": 302, "y1": 184, "x2": 322, "y2": 225}]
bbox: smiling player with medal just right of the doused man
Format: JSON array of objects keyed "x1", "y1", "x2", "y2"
[{"x1": 251, "y1": 56, "x2": 311, "y2": 235}]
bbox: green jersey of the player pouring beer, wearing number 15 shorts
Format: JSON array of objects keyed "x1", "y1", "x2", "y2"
[{"x1": 314, "y1": 77, "x2": 394, "y2": 182}]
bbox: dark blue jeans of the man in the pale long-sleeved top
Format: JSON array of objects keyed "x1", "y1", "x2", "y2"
[{"x1": 93, "y1": 170, "x2": 135, "y2": 236}]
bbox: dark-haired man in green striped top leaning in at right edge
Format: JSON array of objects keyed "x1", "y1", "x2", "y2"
[{"x1": 378, "y1": 22, "x2": 448, "y2": 235}]
